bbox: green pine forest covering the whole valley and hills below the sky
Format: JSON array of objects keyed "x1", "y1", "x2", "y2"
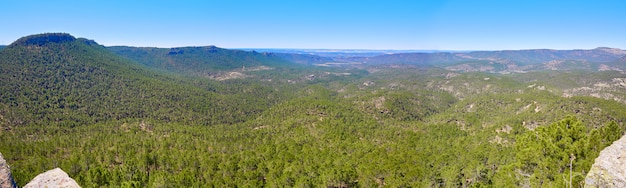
[{"x1": 0, "y1": 33, "x2": 626, "y2": 187}]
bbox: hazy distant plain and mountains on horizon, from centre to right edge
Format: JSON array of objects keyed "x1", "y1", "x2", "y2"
[{"x1": 236, "y1": 47, "x2": 626, "y2": 74}]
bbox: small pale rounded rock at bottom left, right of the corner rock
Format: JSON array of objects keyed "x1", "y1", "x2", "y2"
[{"x1": 24, "y1": 168, "x2": 80, "y2": 188}]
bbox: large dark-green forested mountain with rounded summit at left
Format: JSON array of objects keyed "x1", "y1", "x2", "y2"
[{"x1": 0, "y1": 33, "x2": 282, "y2": 126}]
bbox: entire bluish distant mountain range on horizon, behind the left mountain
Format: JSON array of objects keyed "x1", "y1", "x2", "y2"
[{"x1": 7, "y1": 34, "x2": 626, "y2": 76}]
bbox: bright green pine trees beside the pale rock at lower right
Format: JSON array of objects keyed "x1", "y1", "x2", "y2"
[{"x1": 508, "y1": 117, "x2": 623, "y2": 187}]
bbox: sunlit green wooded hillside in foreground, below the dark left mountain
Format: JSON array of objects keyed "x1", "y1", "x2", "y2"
[{"x1": 0, "y1": 65, "x2": 625, "y2": 187}]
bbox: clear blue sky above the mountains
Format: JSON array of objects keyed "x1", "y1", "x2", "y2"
[{"x1": 0, "y1": 0, "x2": 626, "y2": 50}]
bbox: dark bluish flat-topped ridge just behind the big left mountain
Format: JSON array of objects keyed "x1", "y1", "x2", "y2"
[{"x1": 108, "y1": 46, "x2": 290, "y2": 76}]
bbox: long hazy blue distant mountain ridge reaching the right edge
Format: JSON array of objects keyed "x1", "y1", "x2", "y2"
[{"x1": 343, "y1": 47, "x2": 626, "y2": 73}]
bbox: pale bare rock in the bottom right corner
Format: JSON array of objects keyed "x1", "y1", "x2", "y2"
[{"x1": 585, "y1": 136, "x2": 626, "y2": 187}]
